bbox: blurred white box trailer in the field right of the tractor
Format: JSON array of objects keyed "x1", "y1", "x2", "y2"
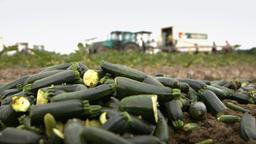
[{"x1": 158, "y1": 26, "x2": 223, "y2": 52}]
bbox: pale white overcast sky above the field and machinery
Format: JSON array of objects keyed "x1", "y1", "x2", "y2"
[{"x1": 0, "y1": 0, "x2": 256, "y2": 53}]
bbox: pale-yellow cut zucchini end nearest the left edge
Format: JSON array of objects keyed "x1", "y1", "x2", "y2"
[{"x1": 11, "y1": 96, "x2": 30, "y2": 112}]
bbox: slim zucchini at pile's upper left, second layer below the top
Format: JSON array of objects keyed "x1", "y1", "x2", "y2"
[{"x1": 24, "y1": 70, "x2": 63, "y2": 84}]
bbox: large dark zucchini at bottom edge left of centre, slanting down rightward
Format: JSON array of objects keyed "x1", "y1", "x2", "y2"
[{"x1": 81, "y1": 127, "x2": 133, "y2": 144}]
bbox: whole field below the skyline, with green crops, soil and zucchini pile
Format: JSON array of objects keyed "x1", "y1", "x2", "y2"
[{"x1": 0, "y1": 60, "x2": 256, "y2": 144}]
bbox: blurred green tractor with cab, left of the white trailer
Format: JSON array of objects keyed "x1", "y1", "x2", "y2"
[{"x1": 89, "y1": 31, "x2": 148, "y2": 53}]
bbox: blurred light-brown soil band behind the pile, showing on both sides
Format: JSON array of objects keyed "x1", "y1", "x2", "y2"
[{"x1": 0, "y1": 65, "x2": 256, "y2": 83}]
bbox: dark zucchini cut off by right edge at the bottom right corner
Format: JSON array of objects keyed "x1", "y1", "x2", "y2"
[{"x1": 240, "y1": 113, "x2": 256, "y2": 141}]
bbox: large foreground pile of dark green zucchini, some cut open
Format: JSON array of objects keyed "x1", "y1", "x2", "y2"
[{"x1": 0, "y1": 62, "x2": 256, "y2": 144}]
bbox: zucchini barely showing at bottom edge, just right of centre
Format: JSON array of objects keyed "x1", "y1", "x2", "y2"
[{"x1": 127, "y1": 135, "x2": 162, "y2": 144}]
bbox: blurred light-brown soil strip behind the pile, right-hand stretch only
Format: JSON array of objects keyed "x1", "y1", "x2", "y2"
[{"x1": 138, "y1": 65, "x2": 256, "y2": 80}]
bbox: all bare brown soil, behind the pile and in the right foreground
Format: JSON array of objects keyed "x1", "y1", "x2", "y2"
[{"x1": 0, "y1": 65, "x2": 256, "y2": 144}]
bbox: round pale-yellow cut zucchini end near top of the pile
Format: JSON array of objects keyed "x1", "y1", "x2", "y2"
[{"x1": 83, "y1": 69, "x2": 99, "y2": 87}]
